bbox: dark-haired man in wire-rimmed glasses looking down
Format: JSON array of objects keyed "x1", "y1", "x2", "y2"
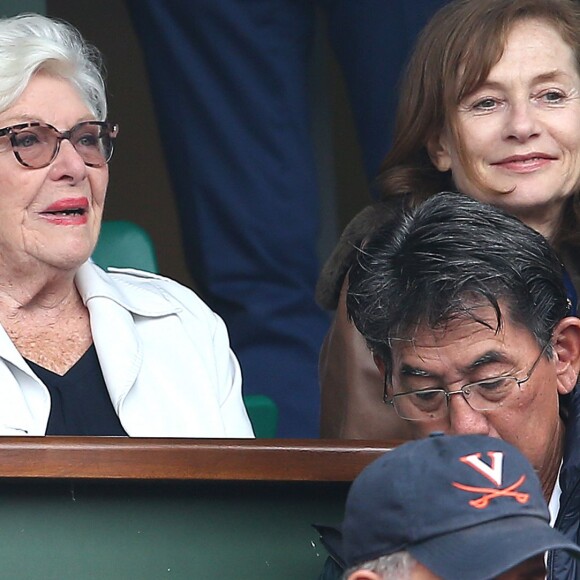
[{"x1": 347, "y1": 193, "x2": 580, "y2": 578}]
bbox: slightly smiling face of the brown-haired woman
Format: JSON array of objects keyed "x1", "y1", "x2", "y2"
[{"x1": 430, "y1": 19, "x2": 580, "y2": 236}]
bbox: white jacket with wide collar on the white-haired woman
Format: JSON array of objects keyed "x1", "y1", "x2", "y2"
[{"x1": 0, "y1": 261, "x2": 253, "y2": 437}]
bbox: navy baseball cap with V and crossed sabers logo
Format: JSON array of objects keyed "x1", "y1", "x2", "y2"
[{"x1": 340, "y1": 434, "x2": 580, "y2": 580}]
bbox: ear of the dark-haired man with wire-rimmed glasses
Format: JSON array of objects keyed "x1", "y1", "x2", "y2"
[{"x1": 552, "y1": 316, "x2": 580, "y2": 395}]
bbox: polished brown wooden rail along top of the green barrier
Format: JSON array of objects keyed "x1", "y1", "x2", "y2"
[{"x1": 0, "y1": 437, "x2": 400, "y2": 482}]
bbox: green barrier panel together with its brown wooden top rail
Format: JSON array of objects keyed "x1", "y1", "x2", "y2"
[{"x1": 0, "y1": 437, "x2": 404, "y2": 580}]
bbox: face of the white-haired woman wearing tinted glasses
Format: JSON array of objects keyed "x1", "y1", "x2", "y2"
[{"x1": 0, "y1": 73, "x2": 108, "y2": 271}]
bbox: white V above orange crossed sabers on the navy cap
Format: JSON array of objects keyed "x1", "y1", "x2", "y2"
[{"x1": 453, "y1": 451, "x2": 530, "y2": 509}]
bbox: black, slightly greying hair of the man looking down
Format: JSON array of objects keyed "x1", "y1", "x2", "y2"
[{"x1": 347, "y1": 192, "x2": 569, "y2": 369}]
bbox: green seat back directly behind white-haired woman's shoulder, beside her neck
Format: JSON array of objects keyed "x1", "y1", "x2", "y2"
[{"x1": 92, "y1": 220, "x2": 159, "y2": 273}]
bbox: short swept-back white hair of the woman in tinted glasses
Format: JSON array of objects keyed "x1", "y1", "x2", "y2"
[{"x1": 0, "y1": 14, "x2": 107, "y2": 121}]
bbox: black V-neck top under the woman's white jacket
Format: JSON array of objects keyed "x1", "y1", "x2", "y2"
[{"x1": 26, "y1": 345, "x2": 127, "y2": 436}]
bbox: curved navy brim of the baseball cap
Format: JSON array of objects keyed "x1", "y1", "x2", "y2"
[{"x1": 407, "y1": 516, "x2": 580, "y2": 580}]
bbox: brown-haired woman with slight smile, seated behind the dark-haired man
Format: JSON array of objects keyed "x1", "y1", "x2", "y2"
[{"x1": 317, "y1": 0, "x2": 580, "y2": 439}]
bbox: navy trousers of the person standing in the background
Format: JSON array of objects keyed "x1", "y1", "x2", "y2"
[{"x1": 127, "y1": 0, "x2": 443, "y2": 437}]
